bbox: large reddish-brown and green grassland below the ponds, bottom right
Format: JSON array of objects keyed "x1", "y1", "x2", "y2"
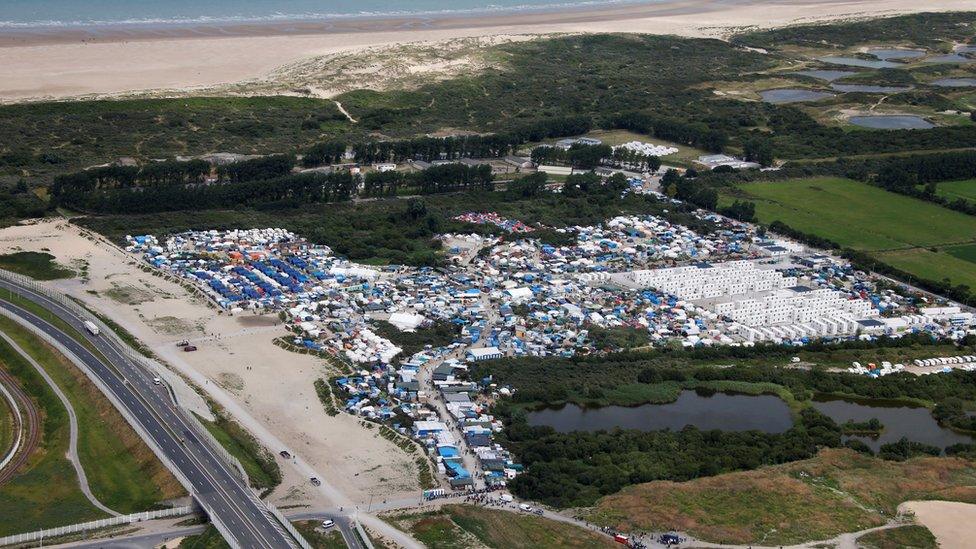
[{"x1": 588, "y1": 450, "x2": 976, "y2": 545}]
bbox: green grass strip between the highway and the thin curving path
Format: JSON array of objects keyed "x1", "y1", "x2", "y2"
[{"x1": 0, "y1": 317, "x2": 184, "y2": 513}]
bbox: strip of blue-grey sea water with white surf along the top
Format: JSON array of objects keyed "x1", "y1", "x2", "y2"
[{"x1": 0, "y1": 0, "x2": 663, "y2": 29}]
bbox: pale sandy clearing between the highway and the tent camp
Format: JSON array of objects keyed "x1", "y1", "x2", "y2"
[{"x1": 0, "y1": 220, "x2": 419, "y2": 507}]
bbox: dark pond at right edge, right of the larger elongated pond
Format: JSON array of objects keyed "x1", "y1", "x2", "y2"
[{"x1": 813, "y1": 398, "x2": 973, "y2": 452}]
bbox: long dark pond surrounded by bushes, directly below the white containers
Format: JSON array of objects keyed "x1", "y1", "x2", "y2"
[{"x1": 528, "y1": 391, "x2": 793, "y2": 433}]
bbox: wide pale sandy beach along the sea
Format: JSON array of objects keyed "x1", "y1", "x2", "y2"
[{"x1": 0, "y1": 0, "x2": 973, "y2": 103}]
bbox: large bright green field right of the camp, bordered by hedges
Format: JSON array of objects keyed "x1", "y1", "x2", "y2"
[{"x1": 721, "y1": 177, "x2": 976, "y2": 287}]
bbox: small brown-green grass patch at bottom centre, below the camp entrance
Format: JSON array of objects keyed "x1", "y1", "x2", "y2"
[{"x1": 387, "y1": 505, "x2": 615, "y2": 549}]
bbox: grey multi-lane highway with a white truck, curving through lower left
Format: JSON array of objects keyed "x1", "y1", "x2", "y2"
[{"x1": 0, "y1": 279, "x2": 296, "y2": 549}]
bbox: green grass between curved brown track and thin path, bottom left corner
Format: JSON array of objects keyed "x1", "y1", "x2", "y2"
[{"x1": 0, "y1": 327, "x2": 105, "y2": 535}]
